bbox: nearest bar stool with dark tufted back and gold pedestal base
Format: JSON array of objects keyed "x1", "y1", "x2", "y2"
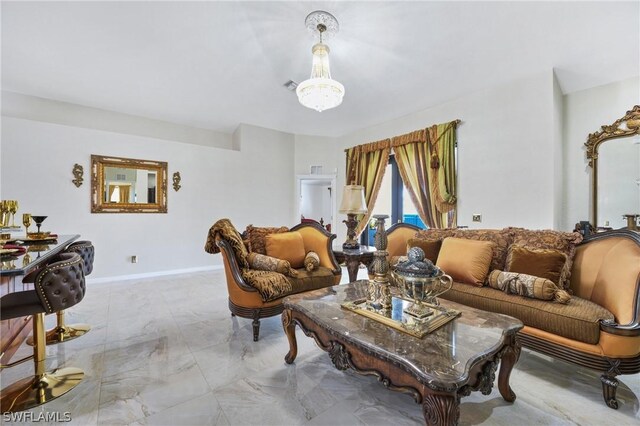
[{"x1": 0, "y1": 253, "x2": 85, "y2": 413}]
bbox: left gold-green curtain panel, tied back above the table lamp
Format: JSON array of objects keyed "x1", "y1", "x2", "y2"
[{"x1": 346, "y1": 139, "x2": 391, "y2": 237}]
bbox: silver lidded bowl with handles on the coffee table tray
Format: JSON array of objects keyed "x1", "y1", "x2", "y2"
[{"x1": 392, "y1": 247, "x2": 453, "y2": 305}]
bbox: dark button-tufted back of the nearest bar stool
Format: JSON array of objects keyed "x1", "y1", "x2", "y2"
[{"x1": 34, "y1": 253, "x2": 86, "y2": 314}]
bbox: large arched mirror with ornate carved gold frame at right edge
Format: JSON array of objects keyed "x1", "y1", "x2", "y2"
[{"x1": 585, "y1": 105, "x2": 640, "y2": 229}]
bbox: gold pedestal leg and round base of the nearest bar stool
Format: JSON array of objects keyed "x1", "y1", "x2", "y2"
[{"x1": 0, "y1": 313, "x2": 84, "y2": 413}]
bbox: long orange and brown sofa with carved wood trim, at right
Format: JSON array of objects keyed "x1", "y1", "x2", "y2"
[{"x1": 388, "y1": 227, "x2": 640, "y2": 408}]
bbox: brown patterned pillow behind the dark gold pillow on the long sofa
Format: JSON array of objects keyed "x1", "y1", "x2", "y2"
[{"x1": 508, "y1": 228, "x2": 582, "y2": 290}]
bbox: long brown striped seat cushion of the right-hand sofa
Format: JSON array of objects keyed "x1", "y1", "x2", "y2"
[{"x1": 440, "y1": 282, "x2": 613, "y2": 345}]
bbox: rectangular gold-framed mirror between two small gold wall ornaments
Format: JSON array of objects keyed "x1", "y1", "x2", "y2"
[{"x1": 91, "y1": 155, "x2": 167, "y2": 213}]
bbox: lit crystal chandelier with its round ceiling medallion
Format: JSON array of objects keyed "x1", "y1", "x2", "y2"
[{"x1": 296, "y1": 10, "x2": 344, "y2": 112}]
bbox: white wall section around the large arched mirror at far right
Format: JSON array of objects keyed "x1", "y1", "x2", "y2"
[{"x1": 561, "y1": 76, "x2": 640, "y2": 229}]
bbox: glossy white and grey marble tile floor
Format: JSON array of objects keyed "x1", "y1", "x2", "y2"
[{"x1": 0, "y1": 271, "x2": 640, "y2": 426}]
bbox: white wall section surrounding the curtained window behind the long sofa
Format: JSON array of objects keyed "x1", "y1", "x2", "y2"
[{"x1": 320, "y1": 71, "x2": 560, "y2": 241}]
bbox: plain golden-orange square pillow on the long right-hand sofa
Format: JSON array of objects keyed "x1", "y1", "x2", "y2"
[{"x1": 436, "y1": 237, "x2": 495, "y2": 286}]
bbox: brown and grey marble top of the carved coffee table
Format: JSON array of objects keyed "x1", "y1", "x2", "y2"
[{"x1": 284, "y1": 280, "x2": 523, "y2": 388}]
